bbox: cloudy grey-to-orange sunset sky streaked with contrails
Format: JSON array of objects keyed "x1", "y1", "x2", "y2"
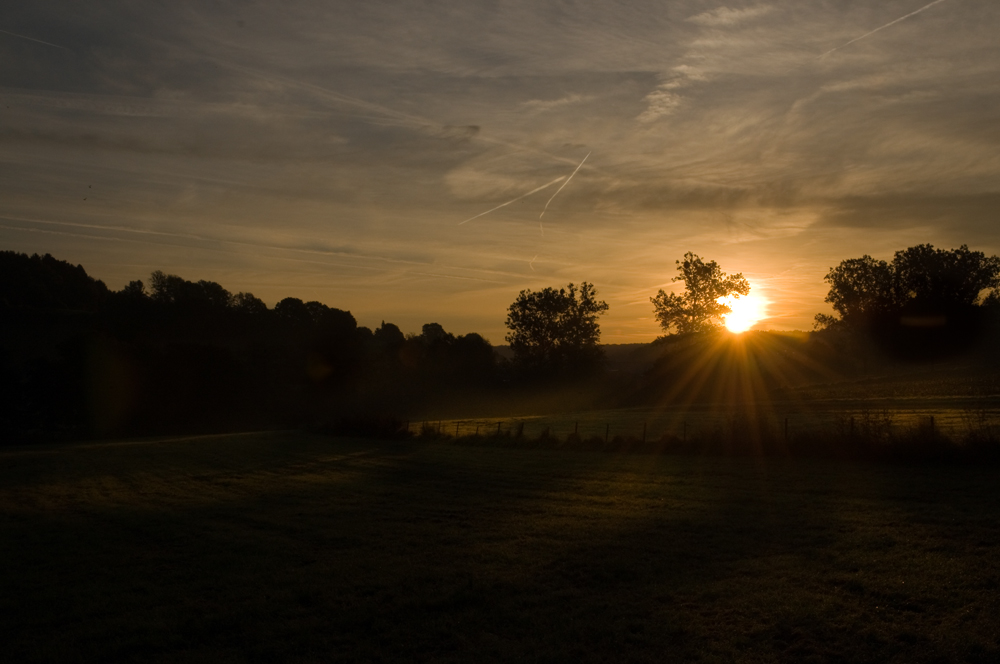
[{"x1": 0, "y1": 0, "x2": 1000, "y2": 343}]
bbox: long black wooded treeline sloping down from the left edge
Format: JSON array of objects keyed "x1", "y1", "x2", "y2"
[{"x1": 0, "y1": 251, "x2": 501, "y2": 442}]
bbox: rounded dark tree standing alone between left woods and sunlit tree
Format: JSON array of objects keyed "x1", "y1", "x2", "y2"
[{"x1": 505, "y1": 281, "x2": 608, "y2": 373}]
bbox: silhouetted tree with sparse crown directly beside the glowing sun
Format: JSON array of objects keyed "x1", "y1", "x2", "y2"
[{"x1": 649, "y1": 251, "x2": 750, "y2": 334}]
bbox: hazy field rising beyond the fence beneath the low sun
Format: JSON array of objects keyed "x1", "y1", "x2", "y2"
[{"x1": 428, "y1": 342, "x2": 1000, "y2": 441}]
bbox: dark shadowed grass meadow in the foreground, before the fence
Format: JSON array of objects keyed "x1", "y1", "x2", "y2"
[{"x1": 0, "y1": 433, "x2": 1000, "y2": 662}]
